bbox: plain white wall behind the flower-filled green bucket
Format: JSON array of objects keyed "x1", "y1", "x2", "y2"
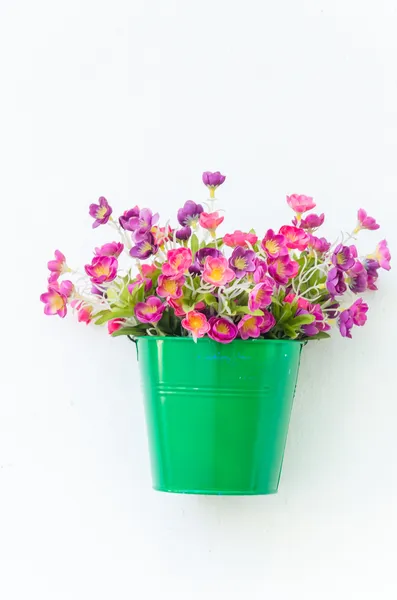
[{"x1": 0, "y1": 0, "x2": 397, "y2": 600}]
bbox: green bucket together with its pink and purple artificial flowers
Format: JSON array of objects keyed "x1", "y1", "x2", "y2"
[{"x1": 41, "y1": 172, "x2": 390, "y2": 494}]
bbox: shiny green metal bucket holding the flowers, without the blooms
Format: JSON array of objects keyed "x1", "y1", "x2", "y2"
[{"x1": 136, "y1": 337, "x2": 303, "y2": 495}]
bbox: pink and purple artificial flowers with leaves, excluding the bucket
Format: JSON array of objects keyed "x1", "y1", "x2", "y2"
[{"x1": 40, "y1": 172, "x2": 390, "y2": 344}]
